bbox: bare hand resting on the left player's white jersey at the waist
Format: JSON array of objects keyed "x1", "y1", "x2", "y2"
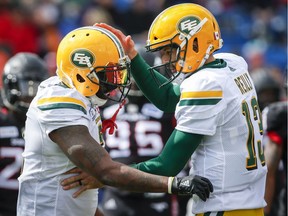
[{"x1": 61, "y1": 168, "x2": 104, "y2": 198}]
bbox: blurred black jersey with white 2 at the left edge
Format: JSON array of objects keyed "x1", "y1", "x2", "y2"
[{"x1": 0, "y1": 108, "x2": 25, "y2": 216}]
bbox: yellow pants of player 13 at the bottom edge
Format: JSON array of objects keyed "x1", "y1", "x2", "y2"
[{"x1": 196, "y1": 208, "x2": 264, "y2": 216}]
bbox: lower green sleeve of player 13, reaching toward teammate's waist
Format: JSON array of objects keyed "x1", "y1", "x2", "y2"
[{"x1": 131, "y1": 129, "x2": 203, "y2": 176}]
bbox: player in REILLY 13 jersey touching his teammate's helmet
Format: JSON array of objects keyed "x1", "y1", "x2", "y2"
[{"x1": 95, "y1": 3, "x2": 267, "y2": 216}]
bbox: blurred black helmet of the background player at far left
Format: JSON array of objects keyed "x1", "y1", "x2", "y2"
[{"x1": 1, "y1": 52, "x2": 49, "y2": 113}]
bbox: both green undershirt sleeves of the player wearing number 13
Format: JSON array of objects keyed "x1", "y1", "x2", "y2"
[{"x1": 131, "y1": 55, "x2": 203, "y2": 176}]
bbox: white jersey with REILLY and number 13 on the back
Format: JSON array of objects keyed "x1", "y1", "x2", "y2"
[{"x1": 175, "y1": 53, "x2": 267, "y2": 213}]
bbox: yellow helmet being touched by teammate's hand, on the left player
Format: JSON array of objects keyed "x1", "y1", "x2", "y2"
[{"x1": 57, "y1": 26, "x2": 130, "y2": 103}]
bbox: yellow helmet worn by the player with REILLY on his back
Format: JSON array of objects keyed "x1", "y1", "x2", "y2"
[{"x1": 146, "y1": 3, "x2": 223, "y2": 84}]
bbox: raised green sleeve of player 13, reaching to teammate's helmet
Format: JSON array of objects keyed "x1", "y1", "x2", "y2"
[{"x1": 131, "y1": 54, "x2": 180, "y2": 112}]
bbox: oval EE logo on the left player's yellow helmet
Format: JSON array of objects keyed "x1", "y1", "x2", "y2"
[{"x1": 71, "y1": 49, "x2": 95, "y2": 68}]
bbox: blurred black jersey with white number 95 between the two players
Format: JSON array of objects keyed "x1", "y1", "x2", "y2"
[{"x1": 103, "y1": 99, "x2": 175, "y2": 164}]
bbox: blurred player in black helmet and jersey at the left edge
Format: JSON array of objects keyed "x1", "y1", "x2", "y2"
[{"x1": 0, "y1": 52, "x2": 49, "y2": 216}]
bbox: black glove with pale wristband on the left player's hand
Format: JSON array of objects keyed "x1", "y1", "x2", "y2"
[{"x1": 168, "y1": 175, "x2": 213, "y2": 201}]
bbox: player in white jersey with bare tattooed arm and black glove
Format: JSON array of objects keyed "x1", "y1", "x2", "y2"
[{"x1": 17, "y1": 26, "x2": 213, "y2": 216}]
